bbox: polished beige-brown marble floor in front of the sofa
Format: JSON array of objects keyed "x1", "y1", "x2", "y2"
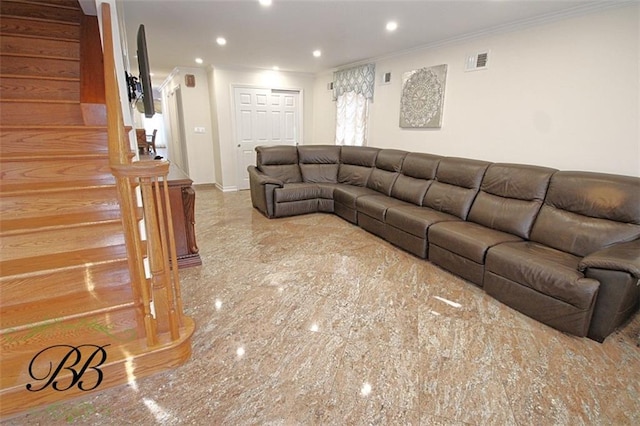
[{"x1": 7, "y1": 187, "x2": 640, "y2": 425}]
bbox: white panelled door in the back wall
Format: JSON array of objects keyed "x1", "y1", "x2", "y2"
[{"x1": 234, "y1": 87, "x2": 301, "y2": 189}]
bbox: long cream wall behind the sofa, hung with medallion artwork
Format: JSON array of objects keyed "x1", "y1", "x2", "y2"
[{"x1": 313, "y1": 3, "x2": 640, "y2": 176}]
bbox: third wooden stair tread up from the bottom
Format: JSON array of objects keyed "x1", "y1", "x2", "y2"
[{"x1": 0, "y1": 244, "x2": 127, "y2": 277}]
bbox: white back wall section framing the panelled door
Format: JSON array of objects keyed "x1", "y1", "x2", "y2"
[{"x1": 209, "y1": 68, "x2": 314, "y2": 191}]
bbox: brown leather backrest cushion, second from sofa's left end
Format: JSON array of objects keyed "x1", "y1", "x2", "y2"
[{"x1": 298, "y1": 145, "x2": 340, "y2": 183}]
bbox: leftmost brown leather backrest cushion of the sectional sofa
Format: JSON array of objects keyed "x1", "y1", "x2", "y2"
[{"x1": 256, "y1": 145, "x2": 302, "y2": 183}]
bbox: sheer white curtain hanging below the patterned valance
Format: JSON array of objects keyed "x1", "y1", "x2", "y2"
[{"x1": 336, "y1": 92, "x2": 369, "y2": 146}]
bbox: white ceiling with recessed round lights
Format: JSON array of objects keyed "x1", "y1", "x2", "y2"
[{"x1": 119, "y1": 0, "x2": 621, "y2": 84}]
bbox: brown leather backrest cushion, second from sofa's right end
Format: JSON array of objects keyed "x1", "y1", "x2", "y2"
[{"x1": 467, "y1": 163, "x2": 556, "y2": 238}]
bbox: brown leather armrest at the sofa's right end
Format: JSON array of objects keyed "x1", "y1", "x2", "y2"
[{"x1": 578, "y1": 239, "x2": 640, "y2": 279}]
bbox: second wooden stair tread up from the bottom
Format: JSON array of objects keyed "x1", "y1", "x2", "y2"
[{"x1": 0, "y1": 283, "x2": 133, "y2": 334}]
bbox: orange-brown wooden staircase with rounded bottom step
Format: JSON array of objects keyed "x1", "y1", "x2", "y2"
[{"x1": 0, "y1": 0, "x2": 194, "y2": 418}]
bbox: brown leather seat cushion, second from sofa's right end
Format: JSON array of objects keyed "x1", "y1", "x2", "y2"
[{"x1": 428, "y1": 221, "x2": 522, "y2": 265}]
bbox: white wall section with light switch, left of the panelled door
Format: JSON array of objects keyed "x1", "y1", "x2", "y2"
[{"x1": 162, "y1": 67, "x2": 216, "y2": 184}]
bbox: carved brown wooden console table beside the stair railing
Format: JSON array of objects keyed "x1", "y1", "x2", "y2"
[{"x1": 167, "y1": 164, "x2": 202, "y2": 269}]
